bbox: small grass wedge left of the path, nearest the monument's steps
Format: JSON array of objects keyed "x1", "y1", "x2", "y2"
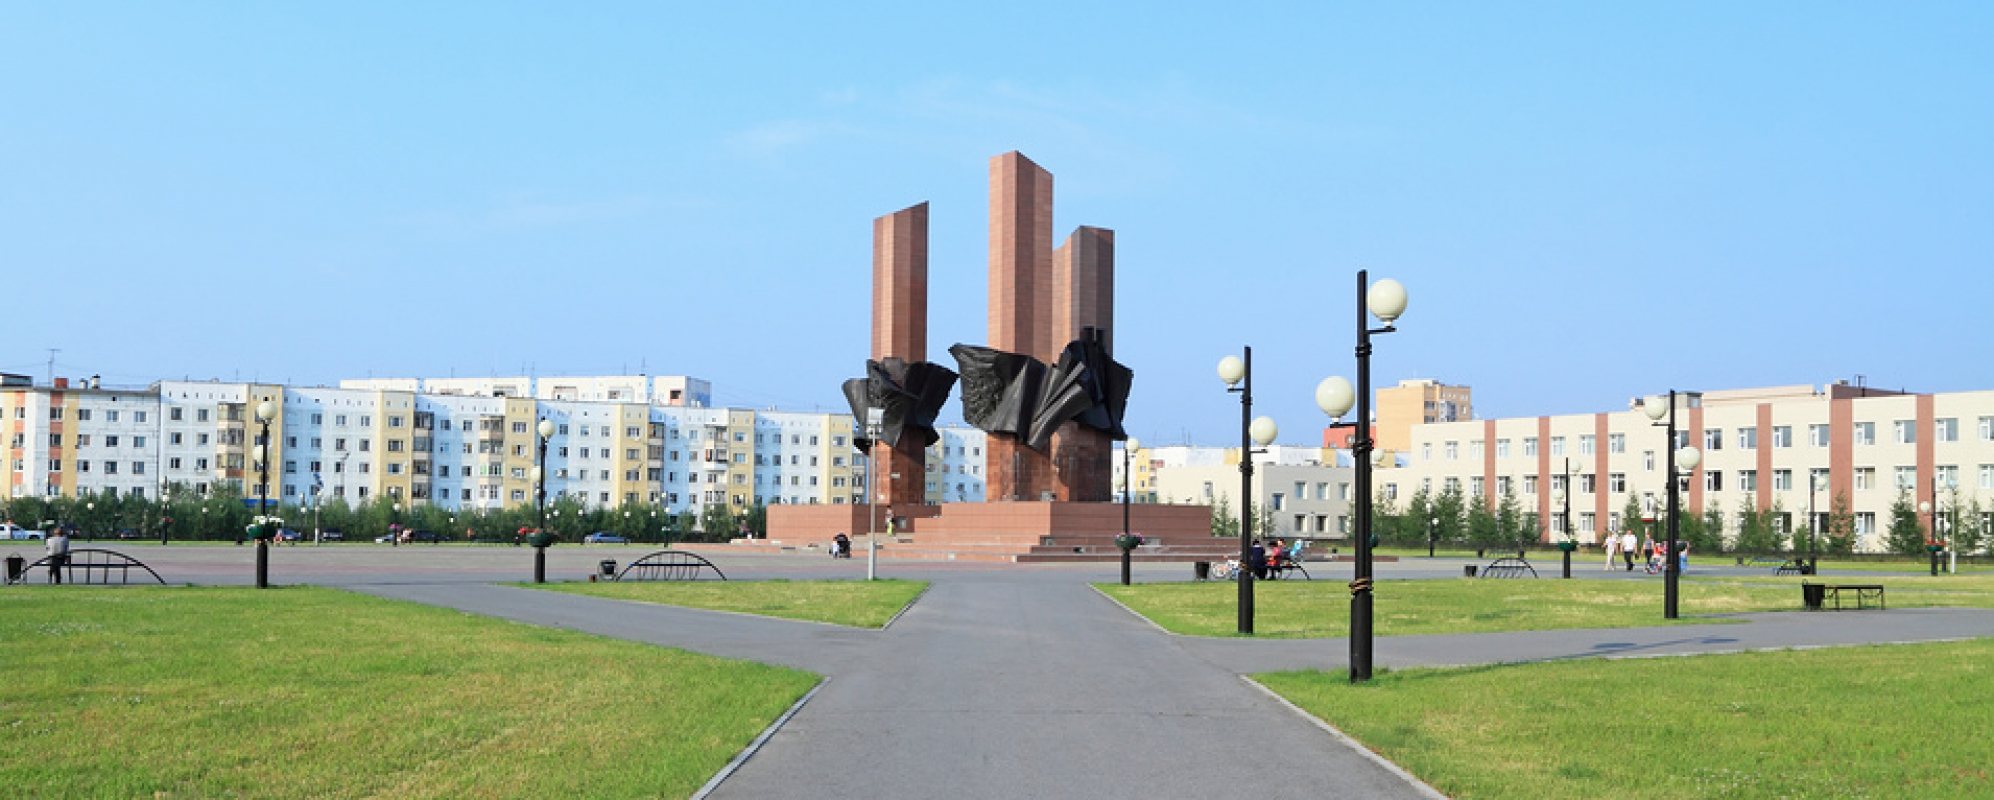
[{"x1": 522, "y1": 581, "x2": 927, "y2": 628}]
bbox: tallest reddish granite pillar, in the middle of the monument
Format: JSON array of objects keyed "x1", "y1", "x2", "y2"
[{"x1": 983, "y1": 150, "x2": 1065, "y2": 501}]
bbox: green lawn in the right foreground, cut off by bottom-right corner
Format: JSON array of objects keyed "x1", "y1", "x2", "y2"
[{"x1": 1256, "y1": 638, "x2": 1994, "y2": 800}]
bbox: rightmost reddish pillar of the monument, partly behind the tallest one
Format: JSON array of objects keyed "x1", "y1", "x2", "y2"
[{"x1": 1051, "y1": 225, "x2": 1117, "y2": 503}]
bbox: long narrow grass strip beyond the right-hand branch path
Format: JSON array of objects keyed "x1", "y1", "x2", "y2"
[{"x1": 1099, "y1": 575, "x2": 1994, "y2": 638}]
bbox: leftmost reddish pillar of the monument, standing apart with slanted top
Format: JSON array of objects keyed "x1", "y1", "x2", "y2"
[{"x1": 867, "y1": 203, "x2": 927, "y2": 507}]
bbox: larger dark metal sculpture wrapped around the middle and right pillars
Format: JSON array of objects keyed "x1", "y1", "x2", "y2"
[{"x1": 949, "y1": 331, "x2": 1135, "y2": 453}]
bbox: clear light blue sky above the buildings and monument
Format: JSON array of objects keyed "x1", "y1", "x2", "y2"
[{"x1": 0, "y1": 0, "x2": 1994, "y2": 445}]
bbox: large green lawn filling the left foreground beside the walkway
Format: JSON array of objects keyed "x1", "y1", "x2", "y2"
[{"x1": 0, "y1": 587, "x2": 818, "y2": 798}]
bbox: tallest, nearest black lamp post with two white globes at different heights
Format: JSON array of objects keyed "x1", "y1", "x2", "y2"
[{"x1": 1316, "y1": 269, "x2": 1406, "y2": 682}]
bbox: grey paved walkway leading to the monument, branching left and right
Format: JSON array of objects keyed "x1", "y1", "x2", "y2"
[{"x1": 355, "y1": 571, "x2": 1994, "y2": 798}]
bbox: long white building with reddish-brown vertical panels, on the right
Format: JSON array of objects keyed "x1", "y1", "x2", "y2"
[{"x1": 1376, "y1": 383, "x2": 1994, "y2": 551}]
